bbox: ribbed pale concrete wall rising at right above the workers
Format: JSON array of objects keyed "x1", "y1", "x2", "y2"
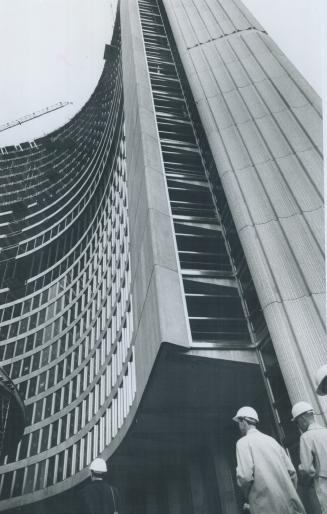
[{"x1": 163, "y1": 0, "x2": 327, "y2": 416}]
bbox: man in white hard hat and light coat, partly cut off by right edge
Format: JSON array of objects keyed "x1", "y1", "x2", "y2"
[{"x1": 292, "y1": 402, "x2": 327, "y2": 514}]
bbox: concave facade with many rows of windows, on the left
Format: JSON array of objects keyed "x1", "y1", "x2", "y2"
[{"x1": 0, "y1": 16, "x2": 135, "y2": 510}]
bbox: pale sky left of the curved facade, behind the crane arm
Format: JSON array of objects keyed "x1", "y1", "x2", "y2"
[{"x1": 0, "y1": 0, "x2": 116, "y2": 146}]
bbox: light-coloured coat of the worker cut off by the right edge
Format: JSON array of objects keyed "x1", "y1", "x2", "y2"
[{"x1": 300, "y1": 423, "x2": 327, "y2": 514}]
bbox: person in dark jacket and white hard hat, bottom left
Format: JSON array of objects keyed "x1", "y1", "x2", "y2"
[{"x1": 76, "y1": 458, "x2": 118, "y2": 514}]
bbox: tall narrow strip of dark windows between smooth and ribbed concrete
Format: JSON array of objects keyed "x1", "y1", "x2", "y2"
[{"x1": 139, "y1": 0, "x2": 251, "y2": 347}]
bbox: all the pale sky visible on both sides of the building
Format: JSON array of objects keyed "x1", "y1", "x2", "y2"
[{"x1": 0, "y1": 0, "x2": 323, "y2": 146}]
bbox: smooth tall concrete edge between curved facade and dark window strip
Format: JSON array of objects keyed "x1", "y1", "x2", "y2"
[{"x1": 121, "y1": 0, "x2": 190, "y2": 401}]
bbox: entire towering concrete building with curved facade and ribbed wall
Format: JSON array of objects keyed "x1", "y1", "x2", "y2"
[{"x1": 0, "y1": 0, "x2": 327, "y2": 514}]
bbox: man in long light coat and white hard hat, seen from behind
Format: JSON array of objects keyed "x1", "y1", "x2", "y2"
[{"x1": 233, "y1": 407, "x2": 305, "y2": 514}]
